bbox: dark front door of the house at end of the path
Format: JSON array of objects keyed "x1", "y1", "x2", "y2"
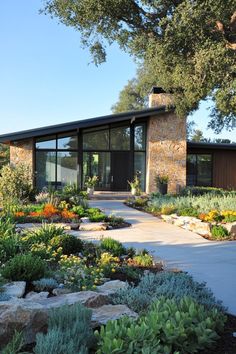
[{"x1": 111, "y1": 151, "x2": 132, "y2": 191}]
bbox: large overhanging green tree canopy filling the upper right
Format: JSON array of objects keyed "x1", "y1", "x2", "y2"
[{"x1": 44, "y1": 0, "x2": 236, "y2": 131}]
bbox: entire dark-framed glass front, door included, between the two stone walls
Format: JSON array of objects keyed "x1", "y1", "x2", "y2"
[{"x1": 35, "y1": 122, "x2": 146, "y2": 191}]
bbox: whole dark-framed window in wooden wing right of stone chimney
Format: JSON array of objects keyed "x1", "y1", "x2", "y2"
[{"x1": 187, "y1": 154, "x2": 212, "y2": 187}]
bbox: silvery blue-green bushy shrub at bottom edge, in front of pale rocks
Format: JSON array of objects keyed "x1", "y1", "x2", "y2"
[{"x1": 34, "y1": 304, "x2": 95, "y2": 354}]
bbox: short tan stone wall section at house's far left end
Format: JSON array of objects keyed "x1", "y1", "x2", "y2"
[{"x1": 10, "y1": 139, "x2": 33, "y2": 173}]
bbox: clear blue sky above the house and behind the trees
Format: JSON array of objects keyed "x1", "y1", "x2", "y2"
[{"x1": 0, "y1": 0, "x2": 235, "y2": 140}]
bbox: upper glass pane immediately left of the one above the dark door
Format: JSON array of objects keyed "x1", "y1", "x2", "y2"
[{"x1": 83, "y1": 130, "x2": 109, "y2": 150}]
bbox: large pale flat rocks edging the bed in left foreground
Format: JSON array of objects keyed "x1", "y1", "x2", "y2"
[{"x1": 0, "y1": 281, "x2": 135, "y2": 348}]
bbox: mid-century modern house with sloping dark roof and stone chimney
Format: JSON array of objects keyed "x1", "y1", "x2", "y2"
[{"x1": 0, "y1": 88, "x2": 236, "y2": 193}]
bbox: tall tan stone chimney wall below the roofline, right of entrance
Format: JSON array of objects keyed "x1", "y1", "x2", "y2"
[{"x1": 146, "y1": 112, "x2": 187, "y2": 193}]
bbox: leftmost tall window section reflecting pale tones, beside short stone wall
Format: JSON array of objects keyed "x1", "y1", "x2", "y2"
[{"x1": 35, "y1": 134, "x2": 78, "y2": 190}]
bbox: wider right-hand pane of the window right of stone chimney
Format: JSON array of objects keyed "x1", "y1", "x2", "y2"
[{"x1": 197, "y1": 155, "x2": 211, "y2": 187}]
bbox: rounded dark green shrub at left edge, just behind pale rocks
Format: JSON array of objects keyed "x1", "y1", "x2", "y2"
[{"x1": 1, "y1": 253, "x2": 46, "y2": 282}]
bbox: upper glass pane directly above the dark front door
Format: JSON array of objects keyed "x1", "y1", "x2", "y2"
[{"x1": 111, "y1": 127, "x2": 130, "y2": 150}]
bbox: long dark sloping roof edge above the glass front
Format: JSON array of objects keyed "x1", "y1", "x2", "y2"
[{"x1": 0, "y1": 106, "x2": 171, "y2": 143}]
